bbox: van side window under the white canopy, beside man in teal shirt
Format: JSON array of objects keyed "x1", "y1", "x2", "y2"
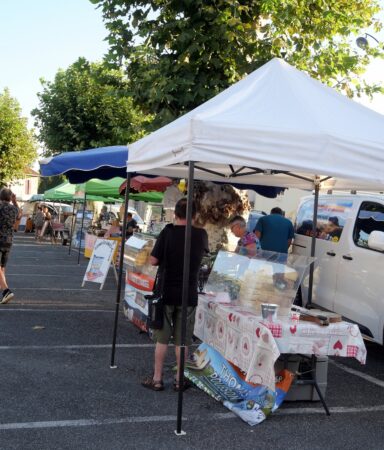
[{"x1": 295, "y1": 198, "x2": 352, "y2": 242}]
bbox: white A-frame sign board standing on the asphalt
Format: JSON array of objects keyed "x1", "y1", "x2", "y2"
[{"x1": 82, "y1": 239, "x2": 117, "y2": 289}]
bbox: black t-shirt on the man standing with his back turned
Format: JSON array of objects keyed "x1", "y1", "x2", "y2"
[{"x1": 152, "y1": 225, "x2": 209, "y2": 306}]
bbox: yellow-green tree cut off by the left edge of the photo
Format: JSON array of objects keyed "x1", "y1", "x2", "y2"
[{"x1": 0, "y1": 89, "x2": 37, "y2": 185}]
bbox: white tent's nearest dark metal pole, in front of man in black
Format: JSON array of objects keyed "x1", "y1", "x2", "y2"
[{"x1": 176, "y1": 161, "x2": 194, "y2": 435}]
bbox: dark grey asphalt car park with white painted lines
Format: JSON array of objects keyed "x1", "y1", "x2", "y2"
[{"x1": 0, "y1": 232, "x2": 384, "y2": 450}]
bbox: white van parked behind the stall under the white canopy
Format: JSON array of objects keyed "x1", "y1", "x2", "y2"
[{"x1": 293, "y1": 194, "x2": 384, "y2": 344}]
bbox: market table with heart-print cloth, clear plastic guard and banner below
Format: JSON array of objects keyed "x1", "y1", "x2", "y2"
[{"x1": 186, "y1": 251, "x2": 366, "y2": 424}]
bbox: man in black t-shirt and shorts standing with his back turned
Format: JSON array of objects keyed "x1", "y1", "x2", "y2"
[{"x1": 142, "y1": 198, "x2": 209, "y2": 391}]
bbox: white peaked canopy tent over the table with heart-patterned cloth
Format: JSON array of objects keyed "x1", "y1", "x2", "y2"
[{"x1": 123, "y1": 59, "x2": 384, "y2": 434}]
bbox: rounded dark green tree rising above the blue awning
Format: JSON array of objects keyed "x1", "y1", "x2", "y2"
[{"x1": 32, "y1": 58, "x2": 151, "y2": 156}]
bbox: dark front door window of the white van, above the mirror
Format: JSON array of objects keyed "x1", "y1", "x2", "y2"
[{"x1": 353, "y1": 202, "x2": 384, "y2": 250}]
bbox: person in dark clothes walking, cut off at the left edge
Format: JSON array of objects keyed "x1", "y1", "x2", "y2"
[{"x1": 0, "y1": 188, "x2": 20, "y2": 305}]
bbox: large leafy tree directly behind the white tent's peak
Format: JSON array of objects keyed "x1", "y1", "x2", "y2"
[{"x1": 90, "y1": 0, "x2": 383, "y2": 126}]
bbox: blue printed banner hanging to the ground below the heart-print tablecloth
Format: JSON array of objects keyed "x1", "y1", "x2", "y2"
[{"x1": 185, "y1": 343, "x2": 293, "y2": 425}]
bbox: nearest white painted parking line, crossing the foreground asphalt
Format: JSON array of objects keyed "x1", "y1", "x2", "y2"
[{"x1": 0, "y1": 405, "x2": 384, "y2": 430}]
